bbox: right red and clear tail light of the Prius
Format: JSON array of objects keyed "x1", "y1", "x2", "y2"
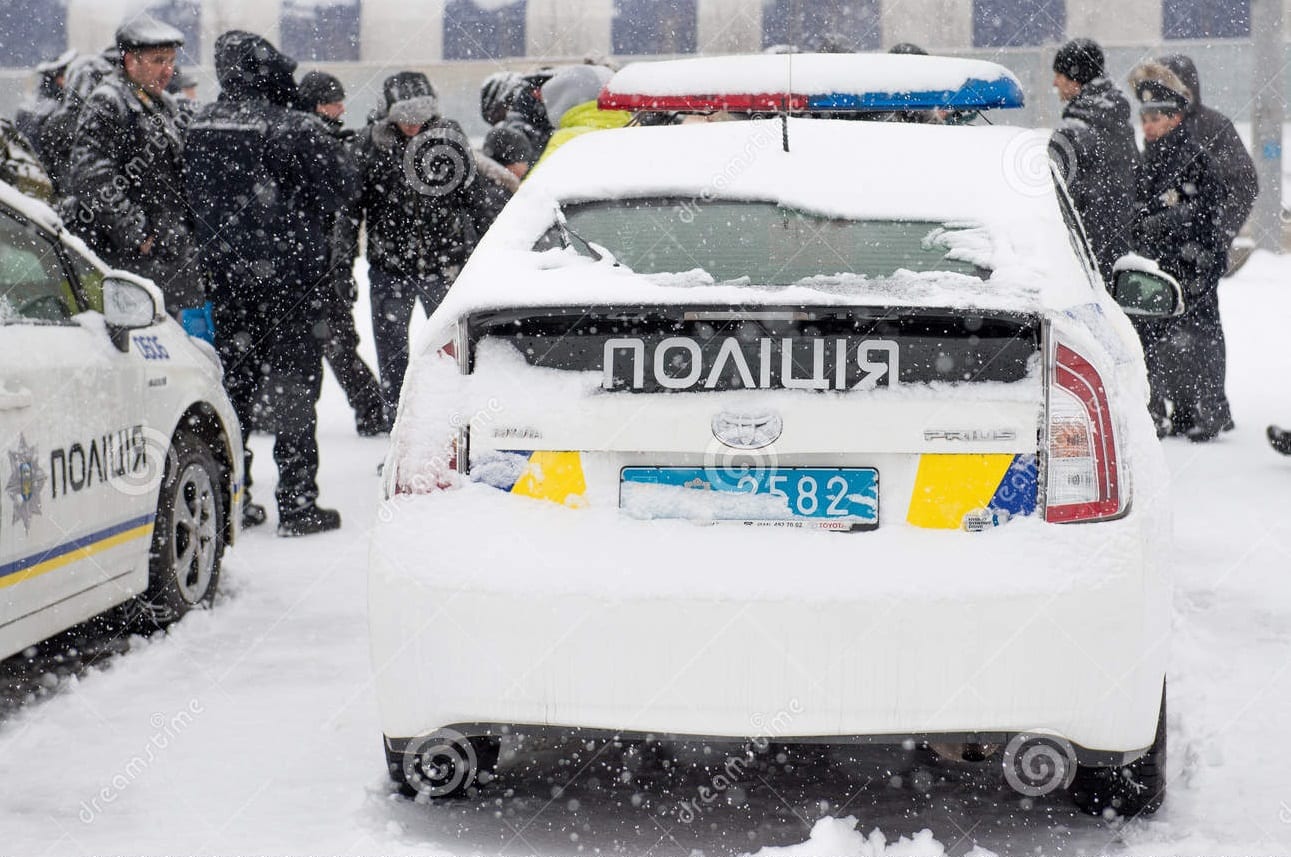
[{"x1": 1044, "y1": 343, "x2": 1123, "y2": 523}]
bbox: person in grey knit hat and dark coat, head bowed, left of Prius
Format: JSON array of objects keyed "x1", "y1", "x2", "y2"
[{"x1": 356, "y1": 72, "x2": 507, "y2": 414}]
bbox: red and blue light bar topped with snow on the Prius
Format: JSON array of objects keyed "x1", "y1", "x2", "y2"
[{"x1": 599, "y1": 54, "x2": 1024, "y2": 112}]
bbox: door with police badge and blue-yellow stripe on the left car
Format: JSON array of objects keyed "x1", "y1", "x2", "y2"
[{"x1": 0, "y1": 208, "x2": 147, "y2": 657}]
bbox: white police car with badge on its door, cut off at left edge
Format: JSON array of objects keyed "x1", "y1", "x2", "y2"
[{"x1": 0, "y1": 183, "x2": 243, "y2": 657}]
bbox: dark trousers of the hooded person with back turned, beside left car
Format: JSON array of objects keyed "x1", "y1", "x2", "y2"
[{"x1": 213, "y1": 293, "x2": 323, "y2": 514}]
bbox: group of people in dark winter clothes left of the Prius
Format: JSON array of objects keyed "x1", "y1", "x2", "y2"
[{"x1": 6, "y1": 14, "x2": 603, "y2": 536}]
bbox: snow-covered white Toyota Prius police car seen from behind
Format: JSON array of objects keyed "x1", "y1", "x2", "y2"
[{"x1": 369, "y1": 55, "x2": 1183, "y2": 813}]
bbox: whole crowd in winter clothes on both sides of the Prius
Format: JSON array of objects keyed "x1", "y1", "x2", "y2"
[{"x1": 5, "y1": 23, "x2": 1291, "y2": 534}]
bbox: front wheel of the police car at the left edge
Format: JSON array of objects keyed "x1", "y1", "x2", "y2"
[{"x1": 139, "y1": 432, "x2": 226, "y2": 627}]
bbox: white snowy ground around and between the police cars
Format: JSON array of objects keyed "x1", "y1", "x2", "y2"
[{"x1": 0, "y1": 256, "x2": 1291, "y2": 857}]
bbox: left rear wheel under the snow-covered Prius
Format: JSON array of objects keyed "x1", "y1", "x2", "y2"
[{"x1": 386, "y1": 729, "x2": 502, "y2": 800}]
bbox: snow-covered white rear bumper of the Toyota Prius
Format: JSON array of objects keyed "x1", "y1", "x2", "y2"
[{"x1": 369, "y1": 487, "x2": 1168, "y2": 754}]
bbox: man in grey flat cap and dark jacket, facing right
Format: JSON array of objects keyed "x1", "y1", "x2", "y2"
[{"x1": 67, "y1": 14, "x2": 205, "y2": 318}]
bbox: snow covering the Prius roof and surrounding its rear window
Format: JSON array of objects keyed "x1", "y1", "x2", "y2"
[{"x1": 442, "y1": 119, "x2": 1103, "y2": 325}]
